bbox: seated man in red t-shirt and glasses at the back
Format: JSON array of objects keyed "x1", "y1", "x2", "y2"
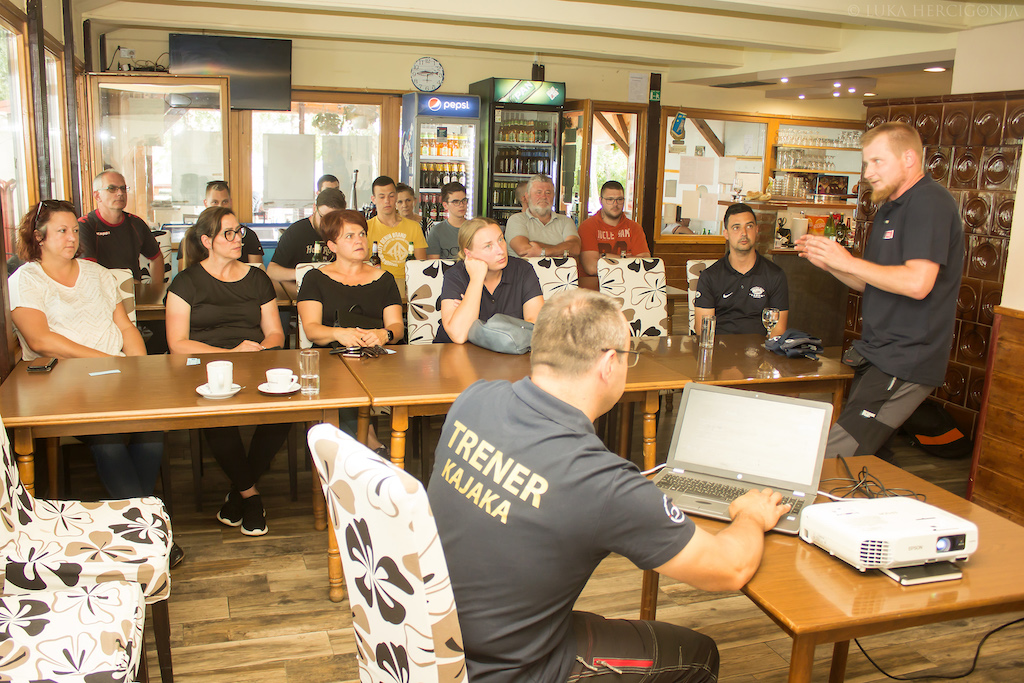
[{"x1": 580, "y1": 180, "x2": 650, "y2": 275}]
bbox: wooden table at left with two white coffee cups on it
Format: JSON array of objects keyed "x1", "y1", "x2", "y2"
[{"x1": 0, "y1": 350, "x2": 370, "y2": 595}]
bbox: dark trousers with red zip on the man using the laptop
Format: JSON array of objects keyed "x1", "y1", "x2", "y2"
[{"x1": 568, "y1": 612, "x2": 718, "y2": 683}]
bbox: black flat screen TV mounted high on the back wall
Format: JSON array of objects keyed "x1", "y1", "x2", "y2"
[{"x1": 169, "y1": 33, "x2": 292, "y2": 112}]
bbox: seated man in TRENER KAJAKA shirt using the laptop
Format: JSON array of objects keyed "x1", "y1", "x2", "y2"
[{"x1": 427, "y1": 289, "x2": 788, "y2": 683}]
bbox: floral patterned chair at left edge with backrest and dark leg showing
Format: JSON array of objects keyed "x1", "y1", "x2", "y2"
[{"x1": 0, "y1": 413, "x2": 173, "y2": 683}]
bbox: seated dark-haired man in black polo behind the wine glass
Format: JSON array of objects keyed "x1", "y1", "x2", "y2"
[{"x1": 693, "y1": 204, "x2": 790, "y2": 335}]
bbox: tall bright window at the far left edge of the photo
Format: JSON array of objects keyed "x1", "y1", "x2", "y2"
[{"x1": 0, "y1": 25, "x2": 29, "y2": 258}]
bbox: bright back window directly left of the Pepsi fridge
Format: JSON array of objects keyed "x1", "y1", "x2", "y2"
[{"x1": 252, "y1": 102, "x2": 381, "y2": 224}]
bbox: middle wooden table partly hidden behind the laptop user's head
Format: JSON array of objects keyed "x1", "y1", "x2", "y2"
[{"x1": 345, "y1": 344, "x2": 689, "y2": 468}]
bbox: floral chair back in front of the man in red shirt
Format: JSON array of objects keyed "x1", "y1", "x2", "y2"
[{"x1": 597, "y1": 256, "x2": 669, "y2": 337}]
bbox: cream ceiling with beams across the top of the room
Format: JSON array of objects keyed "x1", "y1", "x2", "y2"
[{"x1": 74, "y1": 0, "x2": 1024, "y2": 98}]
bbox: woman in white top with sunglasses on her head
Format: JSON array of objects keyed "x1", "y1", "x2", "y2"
[{"x1": 8, "y1": 200, "x2": 184, "y2": 566}]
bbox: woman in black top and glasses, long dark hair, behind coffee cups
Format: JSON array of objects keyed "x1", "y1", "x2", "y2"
[{"x1": 167, "y1": 207, "x2": 291, "y2": 536}]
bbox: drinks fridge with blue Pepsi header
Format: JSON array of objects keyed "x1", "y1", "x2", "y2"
[{"x1": 400, "y1": 92, "x2": 480, "y2": 231}]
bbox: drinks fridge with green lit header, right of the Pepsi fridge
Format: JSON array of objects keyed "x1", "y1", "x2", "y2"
[{"x1": 469, "y1": 78, "x2": 565, "y2": 225}]
